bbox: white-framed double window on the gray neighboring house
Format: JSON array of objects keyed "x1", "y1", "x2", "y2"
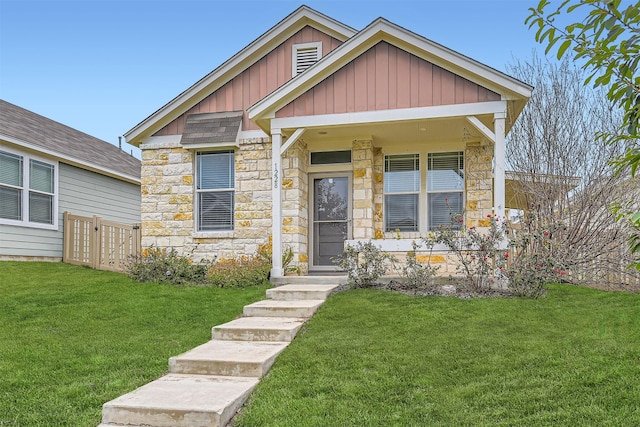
[{"x1": 0, "y1": 151, "x2": 57, "y2": 226}]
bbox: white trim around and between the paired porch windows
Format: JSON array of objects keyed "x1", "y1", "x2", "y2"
[{"x1": 382, "y1": 149, "x2": 467, "y2": 237}]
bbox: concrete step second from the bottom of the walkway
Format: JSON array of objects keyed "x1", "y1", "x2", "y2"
[{"x1": 169, "y1": 340, "x2": 288, "y2": 378}]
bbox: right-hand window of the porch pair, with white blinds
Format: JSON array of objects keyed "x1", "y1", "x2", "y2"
[{"x1": 427, "y1": 151, "x2": 464, "y2": 230}]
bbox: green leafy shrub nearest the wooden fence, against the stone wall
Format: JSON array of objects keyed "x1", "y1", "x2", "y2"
[{"x1": 127, "y1": 246, "x2": 210, "y2": 285}]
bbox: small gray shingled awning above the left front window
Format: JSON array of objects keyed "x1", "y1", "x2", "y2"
[{"x1": 180, "y1": 111, "x2": 243, "y2": 145}]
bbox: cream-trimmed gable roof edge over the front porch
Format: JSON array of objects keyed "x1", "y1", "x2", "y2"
[{"x1": 248, "y1": 18, "x2": 533, "y2": 132}]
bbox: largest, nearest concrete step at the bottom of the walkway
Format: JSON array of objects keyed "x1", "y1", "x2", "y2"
[{"x1": 102, "y1": 374, "x2": 259, "y2": 427}]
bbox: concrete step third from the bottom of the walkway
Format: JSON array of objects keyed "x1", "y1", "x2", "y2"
[{"x1": 212, "y1": 317, "x2": 304, "y2": 342}]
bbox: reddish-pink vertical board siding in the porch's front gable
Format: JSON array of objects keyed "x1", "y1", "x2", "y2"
[{"x1": 276, "y1": 42, "x2": 500, "y2": 117}]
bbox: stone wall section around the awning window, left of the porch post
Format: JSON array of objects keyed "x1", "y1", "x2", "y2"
[{"x1": 142, "y1": 138, "x2": 271, "y2": 259}]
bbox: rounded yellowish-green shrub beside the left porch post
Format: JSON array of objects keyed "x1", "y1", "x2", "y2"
[{"x1": 208, "y1": 255, "x2": 271, "y2": 288}]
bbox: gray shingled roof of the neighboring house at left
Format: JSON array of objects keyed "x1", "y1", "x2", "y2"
[{"x1": 0, "y1": 99, "x2": 140, "y2": 180}]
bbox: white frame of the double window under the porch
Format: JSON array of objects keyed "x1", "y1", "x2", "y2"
[{"x1": 382, "y1": 149, "x2": 467, "y2": 236}]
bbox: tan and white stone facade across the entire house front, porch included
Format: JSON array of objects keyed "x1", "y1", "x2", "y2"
[{"x1": 141, "y1": 138, "x2": 493, "y2": 275}]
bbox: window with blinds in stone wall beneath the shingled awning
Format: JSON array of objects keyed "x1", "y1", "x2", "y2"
[{"x1": 196, "y1": 151, "x2": 235, "y2": 231}]
